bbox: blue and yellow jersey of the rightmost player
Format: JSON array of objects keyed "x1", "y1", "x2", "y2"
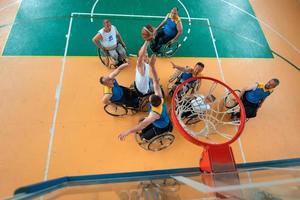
[{"x1": 245, "y1": 83, "x2": 273, "y2": 104}]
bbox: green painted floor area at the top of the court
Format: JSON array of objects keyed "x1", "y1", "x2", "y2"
[{"x1": 3, "y1": 0, "x2": 273, "y2": 58}]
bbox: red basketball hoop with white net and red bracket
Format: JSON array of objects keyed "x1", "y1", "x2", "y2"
[{"x1": 171, "y1": 77, "x2": 245, "y2": 171}]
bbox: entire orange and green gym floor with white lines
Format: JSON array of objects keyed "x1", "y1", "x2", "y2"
[{"x1": 0, "y1": 0, "x2": 300, "y2": 197}]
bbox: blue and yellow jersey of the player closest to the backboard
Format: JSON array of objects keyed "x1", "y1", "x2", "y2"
[{"x1": 151, "y1": 98, "x2": 170, "y2": 128}]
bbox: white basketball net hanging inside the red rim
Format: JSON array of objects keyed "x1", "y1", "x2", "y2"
[{"x1": 175, "y1": 80, "x2": 240, "y2": 144}]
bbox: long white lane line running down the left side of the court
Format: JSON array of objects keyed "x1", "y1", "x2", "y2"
[{"x1": 44, "y1": 12, "x2": 73, "y2": 181}]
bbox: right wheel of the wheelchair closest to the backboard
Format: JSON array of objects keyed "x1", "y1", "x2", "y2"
[{"x1": 148, "y1": 132, "x2": 175, "y2": 151}]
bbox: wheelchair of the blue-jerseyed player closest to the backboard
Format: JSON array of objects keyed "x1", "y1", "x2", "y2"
[{"x1": 135, "y1": 122, "x2": 175, "y2": 152}]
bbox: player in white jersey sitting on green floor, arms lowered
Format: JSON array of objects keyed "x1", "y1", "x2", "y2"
[{"x1": 92, "y1": 19, "x2": 126, "y2": 65}]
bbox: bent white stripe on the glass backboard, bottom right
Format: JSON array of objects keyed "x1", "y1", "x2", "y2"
[{"x1": 171, "y1": 176, "x2": 300, "y2": 193}]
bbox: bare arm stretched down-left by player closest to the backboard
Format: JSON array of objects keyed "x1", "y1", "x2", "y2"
[{"x1": 118, "y1": 112, "x2": 160, "y2": 140}]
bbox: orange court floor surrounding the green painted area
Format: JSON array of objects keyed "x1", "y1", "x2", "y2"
[{"x1": 0, "y1": 0, "x2": 300, "y2": 198}]
